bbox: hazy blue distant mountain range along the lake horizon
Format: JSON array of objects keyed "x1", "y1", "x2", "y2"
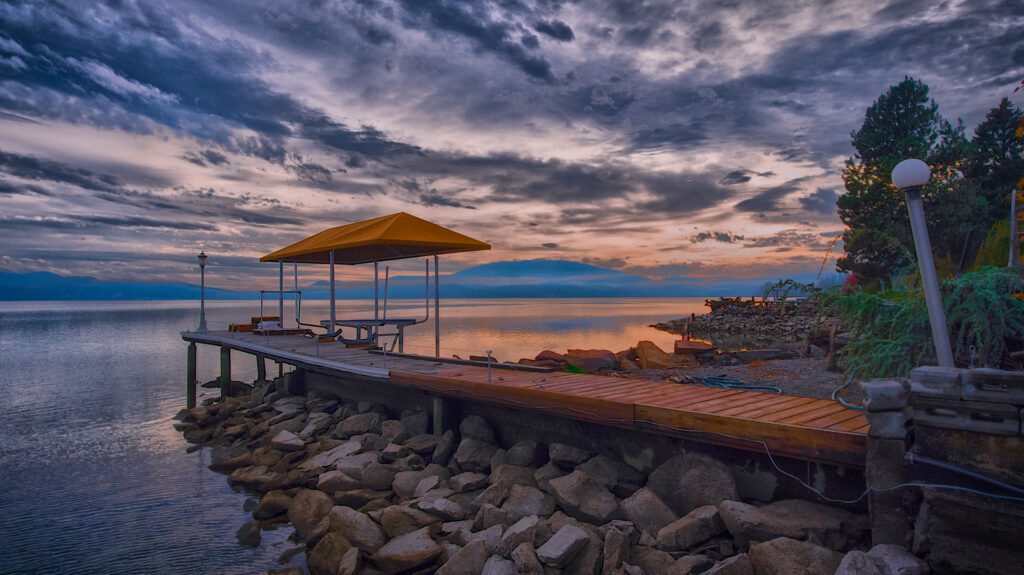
[{"x1": 0, "y1": 260, "x2": 844, "y2": 301}]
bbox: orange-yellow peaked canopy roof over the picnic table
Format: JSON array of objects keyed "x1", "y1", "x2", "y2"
[{"x1": 259, "y1": 212, "x2": 490, "y2": 264}]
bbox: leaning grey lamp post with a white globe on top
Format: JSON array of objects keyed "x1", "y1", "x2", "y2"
[{"x1": 892, "y1": 160, "x2": 953, "y2": 367}]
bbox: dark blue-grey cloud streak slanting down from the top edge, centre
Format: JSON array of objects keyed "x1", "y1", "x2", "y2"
[{"x1": 400, "y1": 0, "x2": 555, "y2": 82}]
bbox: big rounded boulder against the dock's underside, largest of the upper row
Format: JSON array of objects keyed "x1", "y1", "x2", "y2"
[{"x1": 647, "y1": 453, "x2": 739, "y2": 517}]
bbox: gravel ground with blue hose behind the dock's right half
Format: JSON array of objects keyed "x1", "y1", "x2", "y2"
[{"x1": 629, "y1": 358, "x2": 866, "y2": 404}]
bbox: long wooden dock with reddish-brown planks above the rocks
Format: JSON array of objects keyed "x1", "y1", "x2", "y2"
[{"x1": 181, "y1": 331, "x2": 868, "y2": 468}]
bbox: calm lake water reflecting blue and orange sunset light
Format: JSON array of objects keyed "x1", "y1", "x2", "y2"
[{"x1": 0, "y1": 298, "x2": 707, "y2": 574}]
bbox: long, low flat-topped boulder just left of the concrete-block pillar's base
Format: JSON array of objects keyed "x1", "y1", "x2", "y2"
[{"x1": 719, "y1": 499, "x2": 868, "y2": 549}]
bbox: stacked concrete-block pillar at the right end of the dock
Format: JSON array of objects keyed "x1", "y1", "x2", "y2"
[{"x1": 861, "y1": 380, "x2": 910, "y2": 546}]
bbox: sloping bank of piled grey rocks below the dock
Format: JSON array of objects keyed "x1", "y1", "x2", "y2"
[{"x1": 175, "y1": 378, "x2": 928, "y2": 575}]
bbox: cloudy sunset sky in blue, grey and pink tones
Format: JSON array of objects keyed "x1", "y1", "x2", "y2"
[{"x1": 0, "y1": 0, "x2": 1024, "y2": 289}]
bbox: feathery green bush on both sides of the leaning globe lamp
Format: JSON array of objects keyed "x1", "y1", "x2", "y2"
[{"x1": 819, "y1": 267, "x2": 1024, "y2": 380}]
